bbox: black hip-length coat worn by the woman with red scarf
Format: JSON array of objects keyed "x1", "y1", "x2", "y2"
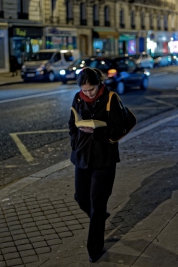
[{"x1": 69, "y1": 87, "x2": 122, "y2": 169}]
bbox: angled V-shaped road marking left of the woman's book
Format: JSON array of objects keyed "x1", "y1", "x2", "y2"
[{"x1": 10, "y1": 129, "x2": 69, "y2": 163}]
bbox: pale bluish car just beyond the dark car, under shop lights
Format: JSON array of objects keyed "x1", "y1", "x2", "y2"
[{"x1": 132, "y1": 52, "x2": 154, "y2": 68}]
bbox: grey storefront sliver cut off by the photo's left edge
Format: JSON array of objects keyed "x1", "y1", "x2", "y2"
[{"x1": 0, "y1": 23, "x2": 9, "y2": 73}]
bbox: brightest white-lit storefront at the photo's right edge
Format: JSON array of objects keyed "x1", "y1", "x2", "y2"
[{"x1": 147, "y1": 31, "x2": 178, "y2": 55}]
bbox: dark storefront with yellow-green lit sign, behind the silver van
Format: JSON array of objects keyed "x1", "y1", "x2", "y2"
[{"x1": 9, "y1": 26, "x2": 43, "y2": 65}]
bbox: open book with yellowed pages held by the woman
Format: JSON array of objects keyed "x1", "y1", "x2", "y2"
[{"x1": 71, "y1": 107, "x2": 107, "y2": 129}]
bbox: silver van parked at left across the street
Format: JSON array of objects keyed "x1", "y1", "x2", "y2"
[{"x1": 21, "y1": 49, "x2": 80, "y2": 82}]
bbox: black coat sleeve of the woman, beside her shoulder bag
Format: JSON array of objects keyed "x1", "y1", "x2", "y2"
[{"x1": 108, "y1": 95, "x2": 124, "y2": 141}]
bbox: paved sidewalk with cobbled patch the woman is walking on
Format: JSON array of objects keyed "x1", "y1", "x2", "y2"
[{"x1": 0, "y1": 110, "x2": 178, "y2": 267}]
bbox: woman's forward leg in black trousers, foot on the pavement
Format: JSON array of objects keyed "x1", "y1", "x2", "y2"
[{"x1": 87, "y1": 164, "x2": 116, "y2": 259}]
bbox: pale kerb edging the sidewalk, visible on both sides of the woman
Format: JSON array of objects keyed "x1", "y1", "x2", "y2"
[{"x1": 0, "y1": 111, "x2": 178, "y2": 200}]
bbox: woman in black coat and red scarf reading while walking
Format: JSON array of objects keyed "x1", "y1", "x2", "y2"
[{"x1": 69, "y1": 67, "x2": 122, "y2": 262}]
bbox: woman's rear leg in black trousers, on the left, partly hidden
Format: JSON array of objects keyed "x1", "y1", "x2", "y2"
[{"x1": 74, "y1": 167, "x2": 92, "y2": 217}]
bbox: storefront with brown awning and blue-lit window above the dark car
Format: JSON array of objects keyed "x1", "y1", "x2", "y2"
[{"x1": 93, "y1": 28, "x2": 119, "y2": 55}]
